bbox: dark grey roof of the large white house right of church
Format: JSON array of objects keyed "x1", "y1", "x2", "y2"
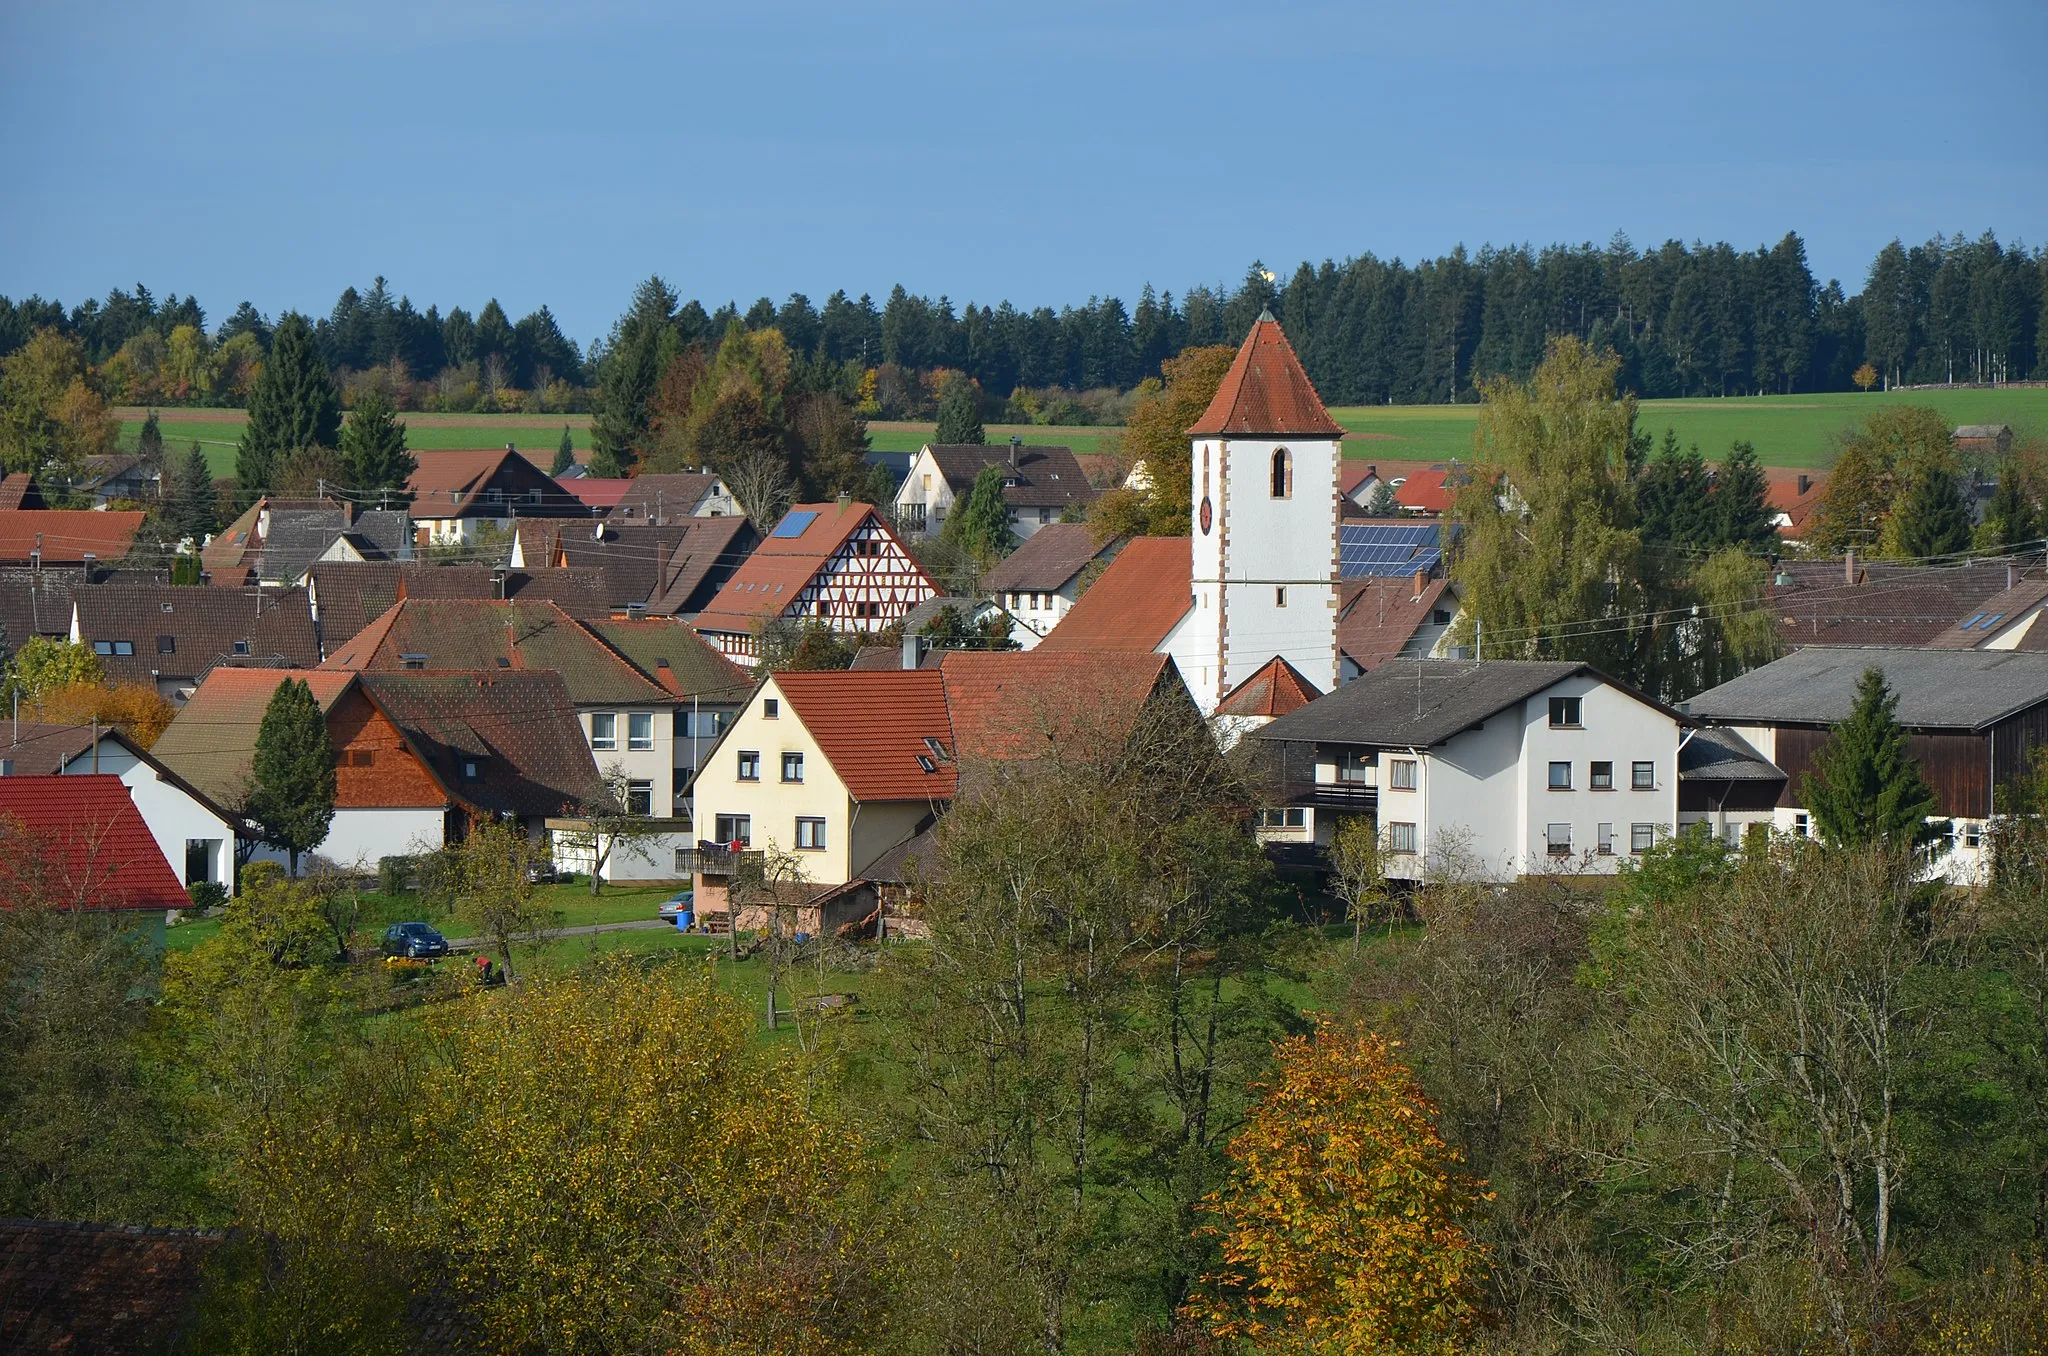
[{"x1": 1253, "y1": 660, "x2": 1589, "y2": 748}]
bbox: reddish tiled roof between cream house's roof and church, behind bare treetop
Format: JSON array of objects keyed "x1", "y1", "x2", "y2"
[{"x1": 938, "y1": 645, "x2": 1174, "y2": 760}]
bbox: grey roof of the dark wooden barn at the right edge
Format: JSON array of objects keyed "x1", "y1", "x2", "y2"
[{"x1": 1686, "y1": 645, "x2": 2048, "y2": 729}]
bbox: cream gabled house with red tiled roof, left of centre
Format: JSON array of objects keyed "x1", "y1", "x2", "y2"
[{"x1": 690, "y1": 670, "x2": 956, "y2": 916}]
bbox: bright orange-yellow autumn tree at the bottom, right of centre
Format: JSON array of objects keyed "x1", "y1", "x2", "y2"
[{"x1": 1188, "y1": 1020, "x2": 1487, "y2": 1356}]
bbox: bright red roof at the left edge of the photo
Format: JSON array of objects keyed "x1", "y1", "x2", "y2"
[{"x1": 0, "y1": 774, "x2": 193, "y2": 909}]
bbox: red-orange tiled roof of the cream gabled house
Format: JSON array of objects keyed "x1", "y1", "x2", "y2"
[{"x1": 774, "y1": 668, "x2": 958, "y2": 801}]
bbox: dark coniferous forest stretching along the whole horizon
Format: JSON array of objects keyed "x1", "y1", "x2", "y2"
[{"x1": 0, "y1": 231, "x2": 2048, "y2": 422}]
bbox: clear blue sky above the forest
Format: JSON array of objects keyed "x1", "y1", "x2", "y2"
[{"x1": 0, "y1": 0, "x2": 2048, "y2": 342}]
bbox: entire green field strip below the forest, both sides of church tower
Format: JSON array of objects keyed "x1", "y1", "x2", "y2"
[{"x1": 121, "y1": 387, "x2": 2048, "y2": 475}]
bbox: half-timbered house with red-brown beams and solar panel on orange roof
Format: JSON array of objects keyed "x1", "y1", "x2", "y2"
[{"x1": 694, "y1": 502, "x2": 938, "y2": 660}]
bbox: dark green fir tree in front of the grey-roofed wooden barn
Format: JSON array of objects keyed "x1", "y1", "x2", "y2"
[{"x1": 1800, "y1": 668, "x2": 1944, "y2": 852}]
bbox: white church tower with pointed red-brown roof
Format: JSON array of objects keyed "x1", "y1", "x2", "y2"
[{"x1": 1182, "y1": 311, "x2": 1343, "y2": 711}]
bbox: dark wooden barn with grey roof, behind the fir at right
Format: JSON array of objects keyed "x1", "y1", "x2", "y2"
[{"x1": 1686, "y1": 645, "x2": 2048, "y2": 883}]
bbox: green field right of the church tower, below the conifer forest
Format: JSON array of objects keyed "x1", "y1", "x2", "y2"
[{"x1": 1331, "y1": 387, "x2": 2048, "y2": 469}]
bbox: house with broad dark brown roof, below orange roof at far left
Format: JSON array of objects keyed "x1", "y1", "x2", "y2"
[{"x1": 70, "y1": 580, "x2": 319, "y2": 705}]
